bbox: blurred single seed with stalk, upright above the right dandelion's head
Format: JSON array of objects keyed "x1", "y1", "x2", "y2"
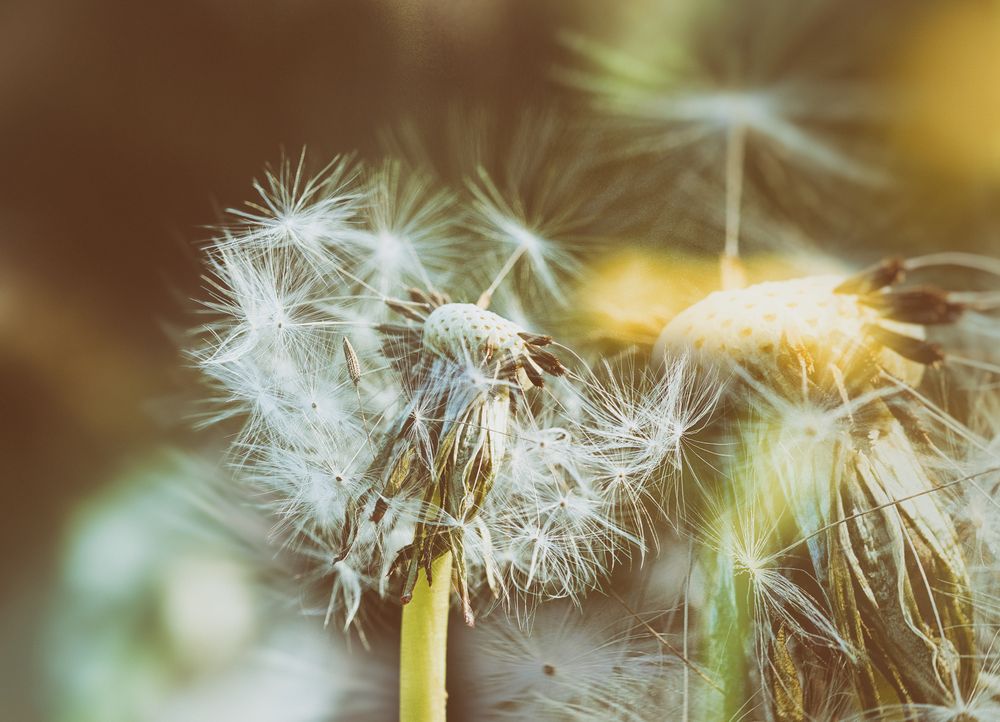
[{"x1": 560, "y1": 3, "x2": 887, "y2": 287}]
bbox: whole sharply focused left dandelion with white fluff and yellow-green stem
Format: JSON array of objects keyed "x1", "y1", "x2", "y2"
[{"x1": 193, "y1": 149, "x2": 668, "y2": 719}]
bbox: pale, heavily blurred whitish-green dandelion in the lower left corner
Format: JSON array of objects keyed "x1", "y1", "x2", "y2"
[{"x1": 44, "y1": 451, "x2": 396, "y2": 722}]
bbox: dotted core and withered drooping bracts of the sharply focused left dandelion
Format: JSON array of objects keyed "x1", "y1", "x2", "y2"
[{"x1": 360, "y1": 293, "x2": 564, "y2": 623}]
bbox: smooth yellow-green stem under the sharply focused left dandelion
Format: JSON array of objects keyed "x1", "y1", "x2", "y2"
[{"x1": 399, "y1": 552, "x2": 451, "y2": 722}]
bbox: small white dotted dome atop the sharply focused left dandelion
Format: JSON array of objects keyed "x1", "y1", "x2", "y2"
[{"x1": 423, "y1": 303, "x2": 526, "y2": 361}]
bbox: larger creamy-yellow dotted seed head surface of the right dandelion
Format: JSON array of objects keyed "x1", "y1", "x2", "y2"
[{"x1": 657, "y1": 275, "x2": 922, "y2": 379}]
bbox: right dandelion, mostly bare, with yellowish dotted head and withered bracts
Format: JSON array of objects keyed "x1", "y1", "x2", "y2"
[{"x1": 660, "y1": 261, "x2": 1000, "y2": 719}]
